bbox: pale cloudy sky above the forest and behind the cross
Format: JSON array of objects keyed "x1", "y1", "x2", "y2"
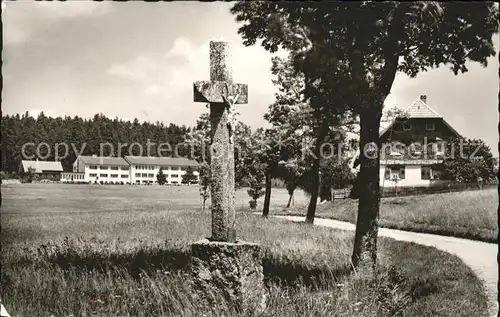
[{"x1": 2, "y1": 1, "x2": 499, "y2": 152}]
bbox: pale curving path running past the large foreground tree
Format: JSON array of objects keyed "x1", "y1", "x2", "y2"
[{"x1": 276, "y1": 216, "x2": 498, "y2": 316}]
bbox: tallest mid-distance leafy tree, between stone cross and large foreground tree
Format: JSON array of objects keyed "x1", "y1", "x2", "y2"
[{"x1": 263, "y1": 55, "x2": 350, "y2": 217}]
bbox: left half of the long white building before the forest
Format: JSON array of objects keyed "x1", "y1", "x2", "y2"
[{"x1": 73, "y1": 155, "x2": 130, "y2": 184}]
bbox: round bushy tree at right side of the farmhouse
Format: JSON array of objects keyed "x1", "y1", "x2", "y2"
[{"x1": 441, "y1": 139, "x2": 496, "y2": 183}]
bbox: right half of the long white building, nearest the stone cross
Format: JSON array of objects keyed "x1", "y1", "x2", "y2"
[{"x1": 125, "y1": 156, "x2": 198, "y2": 184}]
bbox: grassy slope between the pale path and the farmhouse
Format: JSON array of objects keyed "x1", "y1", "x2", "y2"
[{"x1": 278, "y1": 189, "x2": 498, "y2": 243}]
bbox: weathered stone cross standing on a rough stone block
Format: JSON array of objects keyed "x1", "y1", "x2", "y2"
[{"x1": 193, "y1": 42, "x2": 248, "y2": 242}]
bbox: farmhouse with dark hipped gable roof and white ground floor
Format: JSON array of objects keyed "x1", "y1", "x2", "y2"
[{"x1": 380, "y1": 95, "x2": 462, "y2": 187}]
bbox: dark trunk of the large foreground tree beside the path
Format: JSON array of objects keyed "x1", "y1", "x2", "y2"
[{"x1": 352, "y1": 107, "x2": 382, "y2": 272}]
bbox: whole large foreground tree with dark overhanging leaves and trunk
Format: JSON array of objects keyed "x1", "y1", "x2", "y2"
[{"x1": 231, "y1": 1, "x2": 499, "y2": 272}]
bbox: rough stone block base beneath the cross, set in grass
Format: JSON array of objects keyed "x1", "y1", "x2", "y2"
[{"x1": 191, "y1": 239, "x2": 266, "y2": 311}]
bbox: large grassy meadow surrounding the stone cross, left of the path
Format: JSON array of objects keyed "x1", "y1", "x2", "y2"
[{"x1": 1, "y1": 184, "x2": 487, "y2": 317}]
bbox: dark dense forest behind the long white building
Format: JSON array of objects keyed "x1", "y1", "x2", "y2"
[{"x1": 1, "y1": 112, "x2": 190, "y2": 172}]
